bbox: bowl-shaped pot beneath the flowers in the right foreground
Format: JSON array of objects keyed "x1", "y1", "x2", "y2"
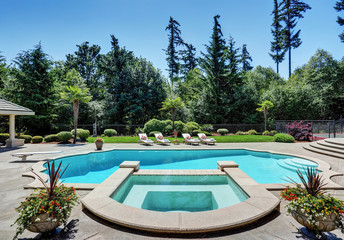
[{"x1": 291, "y1": 208, "x2": 337, "y2": 232}]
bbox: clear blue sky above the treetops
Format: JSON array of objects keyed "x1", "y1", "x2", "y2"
[{"x1": 0, "y1": 0, "x2": 344, "y2": 77}]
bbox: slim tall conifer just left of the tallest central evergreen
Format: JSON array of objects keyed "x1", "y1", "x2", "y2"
[{"x1": 164, "y1": 17, "x2": 183, "y2": 91}]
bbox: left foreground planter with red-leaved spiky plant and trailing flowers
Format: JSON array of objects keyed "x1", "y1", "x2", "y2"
[{"x1": 12, "y1": 161, "x2": 78, "y2": 239}]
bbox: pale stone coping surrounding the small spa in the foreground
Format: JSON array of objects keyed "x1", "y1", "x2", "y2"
[{"x1": 81, "y1": 164, "x2": 280, "y2": 233}]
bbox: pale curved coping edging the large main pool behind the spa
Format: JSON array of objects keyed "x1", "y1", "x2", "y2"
[{"x1": 22, "y1": 145, "x2": 344, "y2": 190}]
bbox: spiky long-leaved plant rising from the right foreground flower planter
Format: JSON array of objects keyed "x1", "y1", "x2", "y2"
[{"x1": 288, "y1": 167, "x2": 327, "y2": 196}]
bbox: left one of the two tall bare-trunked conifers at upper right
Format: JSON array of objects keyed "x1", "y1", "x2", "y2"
[{"x1": 269, "y1": 0, "x2": 286, "y2": 73}]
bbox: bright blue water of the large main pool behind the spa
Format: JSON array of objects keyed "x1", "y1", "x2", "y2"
[{"x1": 45, "y1": 150, "x2": 317, "y2": 183}]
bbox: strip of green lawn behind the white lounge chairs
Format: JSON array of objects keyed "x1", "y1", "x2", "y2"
[{"x1": 87, "y1": 135, "x2": 273, "y2": 143}]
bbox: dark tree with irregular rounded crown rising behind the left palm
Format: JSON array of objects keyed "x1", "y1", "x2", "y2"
[{"x1": 66, "y1": 42, "x2": 103, "y2": 98}]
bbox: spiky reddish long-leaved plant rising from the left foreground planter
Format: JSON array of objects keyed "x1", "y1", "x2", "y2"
[{"x1": 31, "y1": 160, "x2": 69, "y2": 199}]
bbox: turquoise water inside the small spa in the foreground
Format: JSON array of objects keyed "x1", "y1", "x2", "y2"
[{"x1": 111, "y1": 175, "x2": 248, "y2": 212}]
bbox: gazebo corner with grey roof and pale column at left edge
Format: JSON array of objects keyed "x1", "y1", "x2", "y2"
[{"x1": 0, "y1": 98, "x2": 35, "y2": 147}]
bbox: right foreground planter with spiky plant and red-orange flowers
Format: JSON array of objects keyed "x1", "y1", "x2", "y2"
[{"x1": 281, "y1": 167, "x2": 344, "y2": 238}]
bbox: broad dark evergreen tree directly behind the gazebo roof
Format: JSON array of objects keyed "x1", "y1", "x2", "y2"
[{"x1": 8, "y1": 44, "x2": 57, "y2": 134}]
